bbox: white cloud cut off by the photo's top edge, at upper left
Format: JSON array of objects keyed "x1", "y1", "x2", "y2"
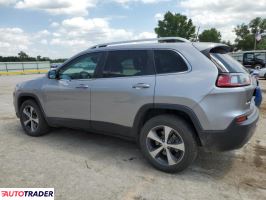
[{"x1": 15, "y1": 0, "x2": 98, "y2": 16}]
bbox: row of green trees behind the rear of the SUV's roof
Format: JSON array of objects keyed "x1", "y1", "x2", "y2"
[{"x1": 154, "y1": 12, "x2": 266, "y2": 51}]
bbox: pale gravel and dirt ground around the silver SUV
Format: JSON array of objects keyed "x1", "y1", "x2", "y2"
[{"x1": 0, "y1": 75, "x2": 266, "y2": 200}]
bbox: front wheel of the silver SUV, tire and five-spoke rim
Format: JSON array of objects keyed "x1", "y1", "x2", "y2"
[{"x1": 19, "y1": 100, "x2": 50, "y2": 137}]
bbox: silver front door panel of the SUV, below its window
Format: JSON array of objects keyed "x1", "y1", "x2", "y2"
[{"x1": 42, "y1": 80, "x2": 92, "y2": 120}]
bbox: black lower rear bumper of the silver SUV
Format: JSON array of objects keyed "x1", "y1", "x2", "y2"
[{"x1": 200, "y1": 108, "x2": 259, "y2": 151}]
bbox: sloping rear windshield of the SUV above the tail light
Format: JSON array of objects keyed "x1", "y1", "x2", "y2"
[{"x1": 211, "y1": 53, "x2": 247, "y2": 73}]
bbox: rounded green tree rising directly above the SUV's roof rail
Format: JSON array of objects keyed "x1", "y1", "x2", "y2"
[{"x1": 154, "y1": 11, "x2": 195, "y2": 39}]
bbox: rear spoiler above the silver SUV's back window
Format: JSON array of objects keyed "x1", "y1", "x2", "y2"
[{"x1": 192, "y1": 42, "x2": 231, "y2": 57}]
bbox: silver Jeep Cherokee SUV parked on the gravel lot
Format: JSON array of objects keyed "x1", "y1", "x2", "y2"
[{"x1": 14, "y1": 38, "x2": 259, "y2": 172}]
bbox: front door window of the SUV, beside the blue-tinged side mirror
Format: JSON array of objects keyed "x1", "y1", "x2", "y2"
[{"x1": 59, "y1": 53, "x2": 101, "y2": 79}]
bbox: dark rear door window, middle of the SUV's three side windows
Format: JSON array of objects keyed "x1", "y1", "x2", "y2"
[{"x1": 103, "y1": 50, "x2": 154, "y2": 78}]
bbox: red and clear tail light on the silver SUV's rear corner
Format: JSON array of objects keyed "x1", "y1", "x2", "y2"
[{"x1": 216, "y1": 73, "x2": 251, "y2": 87}]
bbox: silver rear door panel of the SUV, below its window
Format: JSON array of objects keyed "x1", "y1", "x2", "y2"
[{"x1": 91, "y1": 75, "x2": 155, "y2": 127}]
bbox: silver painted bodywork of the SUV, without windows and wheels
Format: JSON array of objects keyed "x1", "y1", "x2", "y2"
[{"x1": 14, "y1": 43, "x2": 255, "y2": 134}]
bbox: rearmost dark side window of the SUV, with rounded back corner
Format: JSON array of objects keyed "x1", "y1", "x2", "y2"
[{"x1": 154, "y1": 50, "x2": 188, "y2": 74}]
